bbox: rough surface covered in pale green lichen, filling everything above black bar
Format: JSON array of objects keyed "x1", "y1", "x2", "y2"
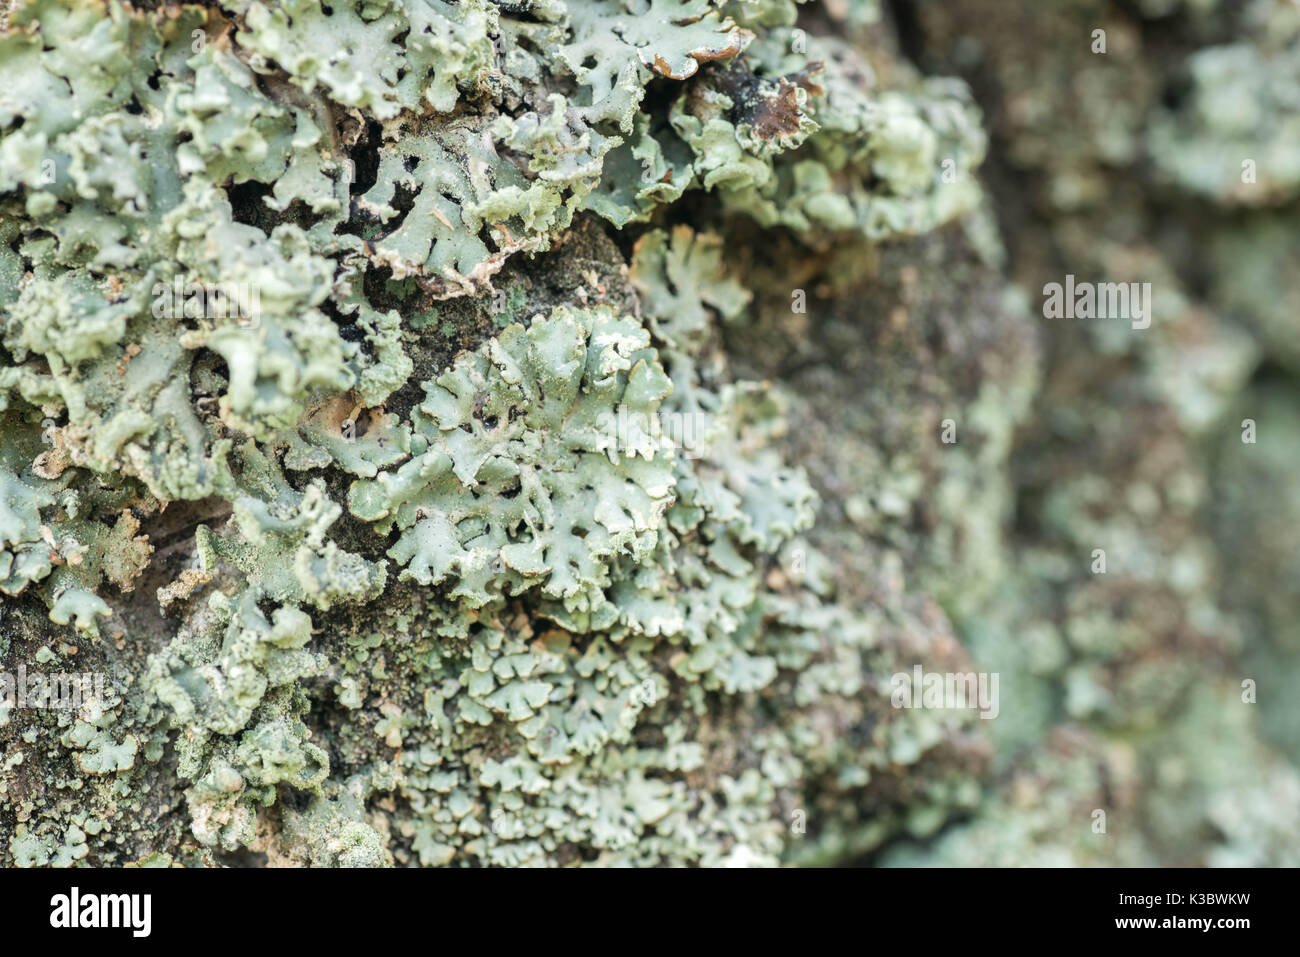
[{"x1": 0, "y1": 0, "x2": 1300, "y2": 866}]
